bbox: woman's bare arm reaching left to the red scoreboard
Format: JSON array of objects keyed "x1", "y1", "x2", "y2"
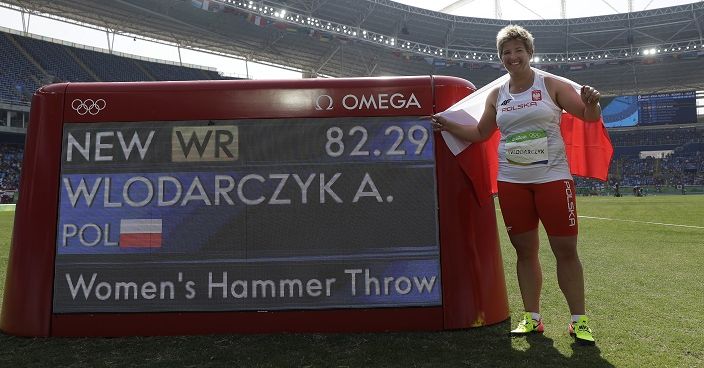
[{"x1": 431, "y1": 88, "x2": 499, "y2": 142}]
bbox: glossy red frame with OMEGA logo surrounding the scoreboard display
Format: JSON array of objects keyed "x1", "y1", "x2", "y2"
[{"x1": 0, "y1": 76, "x2": 508, "y2": 336}]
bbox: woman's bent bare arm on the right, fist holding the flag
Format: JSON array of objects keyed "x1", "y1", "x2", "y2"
[{"x1": 545, "y1": 78, "x2": 601, "y2": 121}]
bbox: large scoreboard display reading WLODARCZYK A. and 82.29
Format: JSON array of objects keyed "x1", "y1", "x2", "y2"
[{"x1": 53, "y1": 117, "x2": 441, "y2": 313}]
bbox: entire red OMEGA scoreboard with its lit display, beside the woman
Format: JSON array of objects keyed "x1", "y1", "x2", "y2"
[{"x1": 0, "y1": 76, "x2": 508, "y2": 336}]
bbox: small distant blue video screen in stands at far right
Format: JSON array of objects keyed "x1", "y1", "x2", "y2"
[{"x1": 638, "y1": 91, "x2": 697, "y2": 125}]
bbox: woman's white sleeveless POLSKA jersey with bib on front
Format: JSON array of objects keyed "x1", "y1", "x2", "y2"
[{"x1": 496, "y1": 73, "x2": 572, "y2": 183}]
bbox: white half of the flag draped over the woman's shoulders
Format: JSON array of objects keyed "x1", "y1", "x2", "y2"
[{"x1": 438, "y1": 67, "x2": 582, "y2": 156}]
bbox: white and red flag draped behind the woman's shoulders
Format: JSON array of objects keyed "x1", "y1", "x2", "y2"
[{"x1": 439, "y1": 68, "x2": 614, "y2": 199}]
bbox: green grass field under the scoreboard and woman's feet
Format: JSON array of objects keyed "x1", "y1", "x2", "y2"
[{"x1": 0, "y1": 196, "x2": 704, "y2": 368}]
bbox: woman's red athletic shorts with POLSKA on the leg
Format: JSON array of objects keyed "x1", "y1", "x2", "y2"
[{"x1": 498, "y1": 180, "x2": 577, "y2": 236}]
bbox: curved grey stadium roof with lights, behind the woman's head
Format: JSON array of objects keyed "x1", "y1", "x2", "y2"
[{"x1": 3, "y1": 0, "x2": 704, "y2": 94}]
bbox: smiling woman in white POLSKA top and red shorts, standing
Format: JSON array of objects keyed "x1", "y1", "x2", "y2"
[{"x1": 431, "y1": 25, "x2": 601, "y2": 344}]
